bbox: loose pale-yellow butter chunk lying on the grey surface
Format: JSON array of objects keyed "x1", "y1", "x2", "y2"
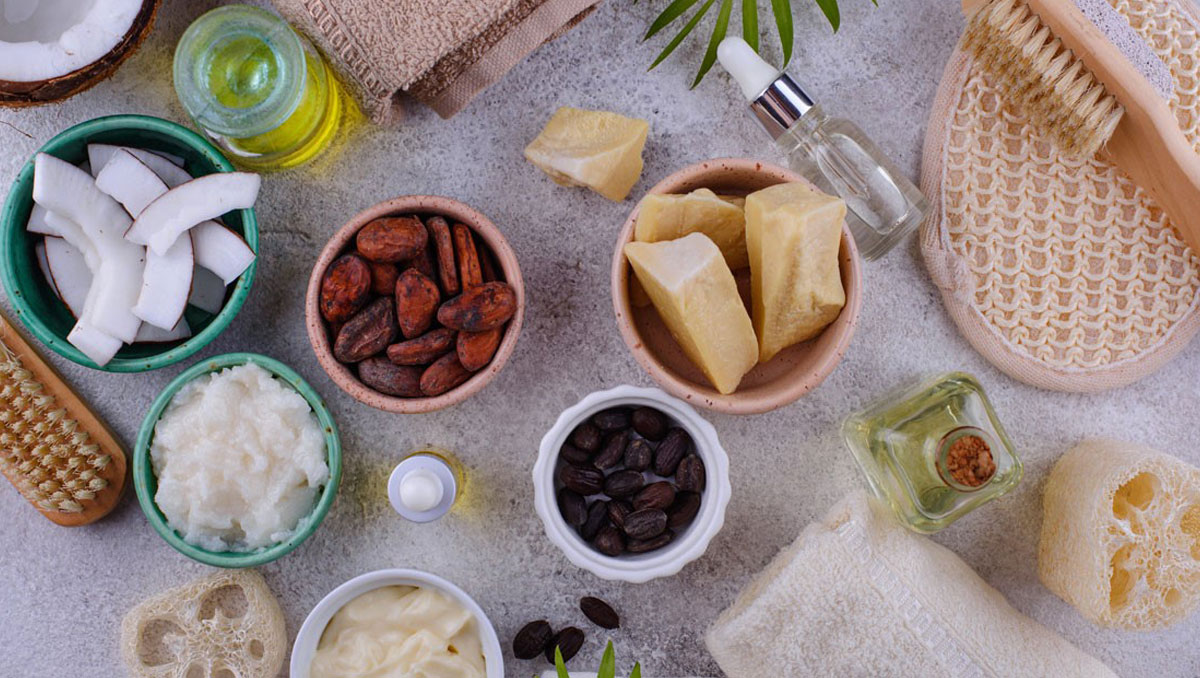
[{"x1": 526, "y1": 107, "x2": 650, "y2": 202}]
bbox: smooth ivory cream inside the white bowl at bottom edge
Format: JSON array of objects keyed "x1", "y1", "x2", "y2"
[{"x1": 310, "y1": 586, "x2": 486, "y2": 678}]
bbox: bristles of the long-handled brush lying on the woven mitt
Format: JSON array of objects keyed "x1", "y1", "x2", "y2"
[{"x1": 962, "y1": 0, "x2": 1124, "y2": 157}]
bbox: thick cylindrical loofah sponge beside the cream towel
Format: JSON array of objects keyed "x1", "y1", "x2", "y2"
[{"x1": 1038, "y1": 439, "x2": 1200, "y2": 630}]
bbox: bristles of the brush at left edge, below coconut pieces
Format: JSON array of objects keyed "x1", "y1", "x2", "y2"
[{"x1": 0, "y1": 350, "x2": 112, "y2": 514}]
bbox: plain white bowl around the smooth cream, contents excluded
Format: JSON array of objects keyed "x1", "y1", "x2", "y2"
[{"x1": 288, "y1": 569, "x2": 504, "y2": 678}]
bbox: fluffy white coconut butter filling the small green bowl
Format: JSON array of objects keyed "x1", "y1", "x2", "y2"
[{"x1": 150, "y1": 362, "x2": 329, "y2": 551}]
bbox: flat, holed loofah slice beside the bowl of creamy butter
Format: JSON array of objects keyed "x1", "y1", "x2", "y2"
[{"x1": 121, "y1": 570, "x2": 288, "y2": 678}]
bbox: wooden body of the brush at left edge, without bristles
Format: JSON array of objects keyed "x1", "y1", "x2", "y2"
[{"x1": 0, "y1": 313, "x2": 126, "y2": 527}]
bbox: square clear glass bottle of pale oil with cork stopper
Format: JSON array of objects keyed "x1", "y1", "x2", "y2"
[{"x1": 842, "y1": 372, "x2": 1022, "y2": 534}]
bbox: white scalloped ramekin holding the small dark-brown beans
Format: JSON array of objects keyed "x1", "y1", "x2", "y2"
[{"x1": 533, "y1": 385, "x2": 731, "y2": 583}]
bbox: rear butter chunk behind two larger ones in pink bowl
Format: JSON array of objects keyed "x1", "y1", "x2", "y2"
[{"x1": 634, "y1": 188, "x2": 750, "y2": 271}]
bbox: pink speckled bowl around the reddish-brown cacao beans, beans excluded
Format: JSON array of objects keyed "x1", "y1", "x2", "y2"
[{"x1": 304, "y1": 196, "x2": 526, "y2": 414}]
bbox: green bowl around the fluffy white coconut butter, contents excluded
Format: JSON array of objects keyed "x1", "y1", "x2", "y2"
[{"x1": 133, "y1": 353, "x2": 342, "y2": 568}]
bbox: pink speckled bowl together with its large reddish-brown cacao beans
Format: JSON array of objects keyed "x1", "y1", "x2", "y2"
[{"x1": 305, "y1": 196, "x2": 524, "y2": 414}]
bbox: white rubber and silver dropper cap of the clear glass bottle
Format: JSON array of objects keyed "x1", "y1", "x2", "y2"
[{"x1": 716, "y1": 37, "x2": 816, "y2": 139}]
